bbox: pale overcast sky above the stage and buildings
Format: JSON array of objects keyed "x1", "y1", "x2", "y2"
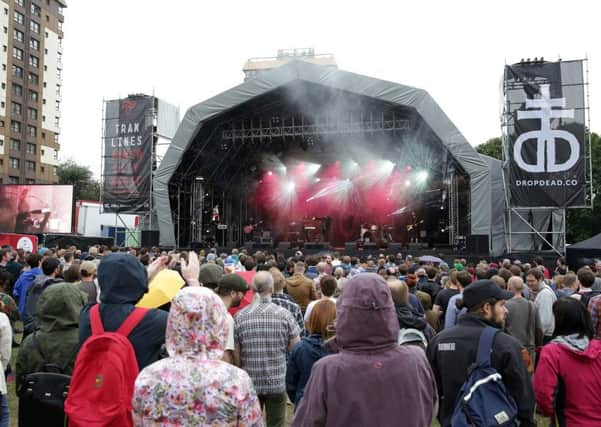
[{"x1": 60, "y1": 0, "x2": 601, "y2": 175}]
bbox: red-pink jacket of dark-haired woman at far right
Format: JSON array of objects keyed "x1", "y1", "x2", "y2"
[{"x1": 534, "y1": 340, "x2": 601, "y2": 427}]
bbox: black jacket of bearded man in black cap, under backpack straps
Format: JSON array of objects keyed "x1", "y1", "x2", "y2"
[{"x1": 427, "y1": 313, "x2": 536, "y2": 427}]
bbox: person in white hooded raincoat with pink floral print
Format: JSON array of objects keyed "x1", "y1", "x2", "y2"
[{"x1": 133, "y1": 287, "x2": 263, "y2": 426}]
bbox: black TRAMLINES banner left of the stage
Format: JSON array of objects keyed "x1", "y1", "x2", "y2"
[{"x1": 102, "y1": 96, "x2": 154, "y2": 213}]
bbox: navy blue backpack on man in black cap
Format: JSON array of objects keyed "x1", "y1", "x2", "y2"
[{"x1": 451, "y1": 326, "x2": 518, "y2": 427}]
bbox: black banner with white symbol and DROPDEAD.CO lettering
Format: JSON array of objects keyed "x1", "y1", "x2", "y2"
[{"x1": 505, "y1": 61, "x2": 586, "y2": 207}]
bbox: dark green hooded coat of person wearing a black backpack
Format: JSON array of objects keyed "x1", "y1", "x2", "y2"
[{"x1": 16, "y1": 283, "x2": 87, "y2": 389}]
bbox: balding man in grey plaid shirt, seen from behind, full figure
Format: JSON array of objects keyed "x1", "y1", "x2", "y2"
[{"x1": 234, "y1": 269, "x2": 304, "y2": 427}]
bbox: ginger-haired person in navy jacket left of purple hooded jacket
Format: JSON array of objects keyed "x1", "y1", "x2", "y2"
[{"x1": 286, "y1": 300, "x2": 336, "y2": 407}]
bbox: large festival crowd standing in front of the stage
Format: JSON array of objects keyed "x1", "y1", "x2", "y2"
[{"x1": 0, "y1": 246, "x2": 601, "y2": 427}]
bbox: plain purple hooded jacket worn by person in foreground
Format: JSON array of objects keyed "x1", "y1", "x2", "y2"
[{"x1": 292, "y1": 273, "x2": 438, "y2": 427}]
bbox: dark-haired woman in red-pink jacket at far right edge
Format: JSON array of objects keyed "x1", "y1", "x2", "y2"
[{"x1": 534, "y1": 298, "x2": 601, "y2": 427}]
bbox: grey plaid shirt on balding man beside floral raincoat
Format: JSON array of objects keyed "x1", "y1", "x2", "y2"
[{"x1": 234, "y1": 297, "x2": 300, "y2": 395}]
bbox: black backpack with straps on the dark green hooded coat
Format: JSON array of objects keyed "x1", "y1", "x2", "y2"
[{"x1": 17, "y1": 333, "x2": 79, "y2": 427}]
